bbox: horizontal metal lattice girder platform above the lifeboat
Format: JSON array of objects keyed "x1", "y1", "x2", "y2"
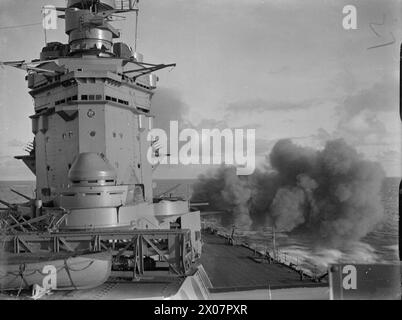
[{"x1": 0, "y1": 229, "x2": 195, "y2": 279}]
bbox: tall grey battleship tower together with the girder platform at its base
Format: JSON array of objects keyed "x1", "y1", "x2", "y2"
[{"x1": 3, "y1": 0, "x2": 207, "y2": 298}]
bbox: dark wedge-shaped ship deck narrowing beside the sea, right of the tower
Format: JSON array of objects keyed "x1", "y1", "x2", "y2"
[{"x1": 201, "y1": 232, "x2": 328, "y2": 292}]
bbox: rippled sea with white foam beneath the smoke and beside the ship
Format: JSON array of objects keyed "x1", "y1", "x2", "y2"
[{"x1": 0, "y1": 178, "x2": 400, "y2": 272}]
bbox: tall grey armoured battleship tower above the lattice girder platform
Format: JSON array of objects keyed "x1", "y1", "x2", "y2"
[{"x1": 11, "y1": 0, "x2": 203, "y2": 235}]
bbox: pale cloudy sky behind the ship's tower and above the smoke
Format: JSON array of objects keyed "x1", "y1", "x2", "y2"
[{"x1": 0, "y1": 0, "x2": 402, "y2": 180}]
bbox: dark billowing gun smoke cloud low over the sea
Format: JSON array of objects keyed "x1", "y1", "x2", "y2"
[{"x1": 193, "y1": 140, "x2": 384, "y2": 247}]
